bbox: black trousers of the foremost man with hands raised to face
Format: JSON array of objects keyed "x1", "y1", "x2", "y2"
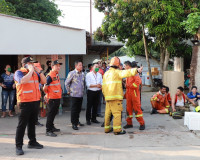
[{"x1": 15, "y1": 101, "x2": 39, "y2": 147}]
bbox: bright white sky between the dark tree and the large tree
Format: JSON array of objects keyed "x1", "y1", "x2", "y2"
[{"x1": 55, "y1": 0, "x2": 104, "y2": 31}]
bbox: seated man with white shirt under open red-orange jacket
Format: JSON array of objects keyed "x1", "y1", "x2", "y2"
[{"x1": 170, "y1": 87, "x2": 195, "y2": 116}]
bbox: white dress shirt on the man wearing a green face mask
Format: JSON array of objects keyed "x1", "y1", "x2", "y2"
[{"x1": 86, "y1": 71, "x2": 102, "y2": 91}]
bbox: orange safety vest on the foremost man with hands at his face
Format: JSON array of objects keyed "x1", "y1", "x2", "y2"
[{"x1": 15, "y1": 68, "x2": 41, "y2": 102}]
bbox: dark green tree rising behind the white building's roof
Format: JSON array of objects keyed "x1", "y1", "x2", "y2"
[{"x1": 6, "y1": 0, "x2": 62, "y2": 24}]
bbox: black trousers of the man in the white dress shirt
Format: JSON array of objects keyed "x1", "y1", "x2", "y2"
[{"x1": 86, "y1": 90, "x2": 101, "y2": 121}]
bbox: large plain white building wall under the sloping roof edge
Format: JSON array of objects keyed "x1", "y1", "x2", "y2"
[{"x1": 0, "y1": 14, "x2": 86, "y2": 55}]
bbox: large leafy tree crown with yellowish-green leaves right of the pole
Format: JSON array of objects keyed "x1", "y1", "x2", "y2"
[{"x1": 95, "y1": 0, "x2": 200, "y2": 73}]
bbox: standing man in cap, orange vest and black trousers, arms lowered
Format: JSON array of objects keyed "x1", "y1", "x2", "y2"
[{"x1": 43, "y1": 60, "x2": 62, "y2": 137}]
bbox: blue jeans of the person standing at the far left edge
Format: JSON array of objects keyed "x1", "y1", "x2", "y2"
[{"x1": 1, "y1": 90, "x2": 16, "y2": 112}]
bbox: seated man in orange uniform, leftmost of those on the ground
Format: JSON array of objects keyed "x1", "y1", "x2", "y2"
[{"x1": 151, "y1": 86, "x2": 170, "y2": 114}]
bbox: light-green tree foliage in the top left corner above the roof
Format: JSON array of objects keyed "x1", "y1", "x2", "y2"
[{"x1": 0, "y1": 0, "x2": 15, "y2": 15}]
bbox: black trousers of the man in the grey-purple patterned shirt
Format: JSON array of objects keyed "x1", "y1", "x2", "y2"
[{"x1": 71, "y1": 97, "x2": 83, "y2": 125}]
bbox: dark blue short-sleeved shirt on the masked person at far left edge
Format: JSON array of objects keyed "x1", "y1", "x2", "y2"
[{"x1": 0, "y1": 73, "x2": 14, "y2": 91}]
